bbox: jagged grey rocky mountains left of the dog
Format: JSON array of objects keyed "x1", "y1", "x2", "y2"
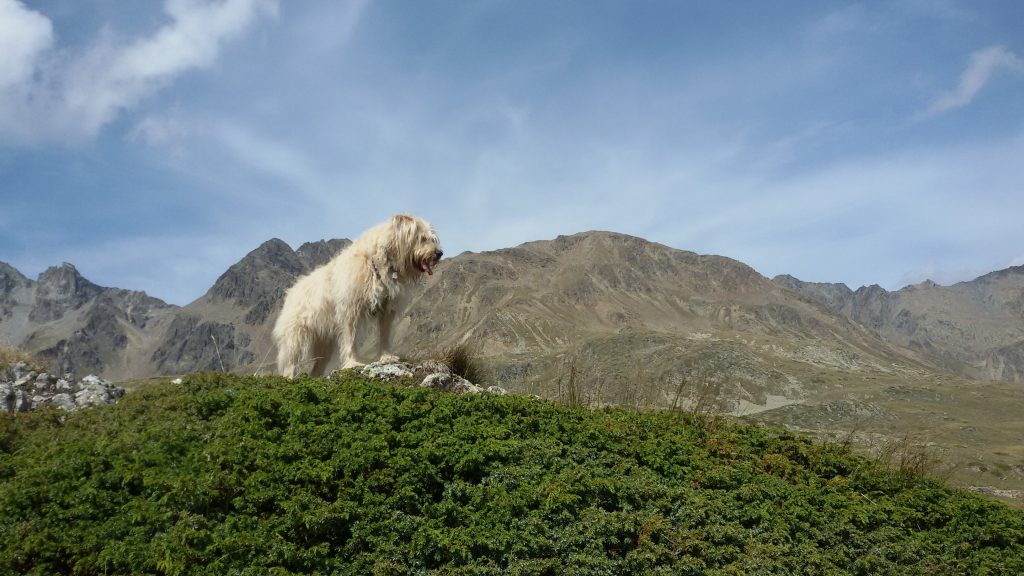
[{"x1": 0, "y1": 239, "x2": 349, "y2": 380}]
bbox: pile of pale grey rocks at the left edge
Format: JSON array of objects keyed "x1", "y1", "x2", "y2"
[{"x1": 0, "y1": 362, "x2": 125, "y2": 413}]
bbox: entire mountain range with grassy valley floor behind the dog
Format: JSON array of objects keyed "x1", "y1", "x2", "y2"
[{"x1": 0, "y1": 232, "x2": 1024, "y2": 490}]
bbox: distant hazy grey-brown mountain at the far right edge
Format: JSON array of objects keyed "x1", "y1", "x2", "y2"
[{"x1": 774, "y1": 266, "x2": 1024, "y2": 382}]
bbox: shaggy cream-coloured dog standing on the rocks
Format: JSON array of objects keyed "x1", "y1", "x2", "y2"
[{"x1": 273, "y1": 214, "x2": 441, "y2": 378}]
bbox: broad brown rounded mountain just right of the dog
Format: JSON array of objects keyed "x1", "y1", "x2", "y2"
[{"x1": 398, "y1": 232, "x2": 927, "y2": 408}]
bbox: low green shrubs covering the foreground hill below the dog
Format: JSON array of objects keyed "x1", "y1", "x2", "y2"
[{"x1": 0, "y1": 374, "x2": 1024, "y2": 575}]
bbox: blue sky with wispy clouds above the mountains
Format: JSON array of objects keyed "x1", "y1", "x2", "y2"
[{"x1": 0, "y1": 0, "x2": 1024, "y2": 304}]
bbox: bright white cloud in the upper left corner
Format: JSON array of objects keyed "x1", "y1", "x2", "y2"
[{"x1": 0, "y1": 0, "x2": 278, "y2": 140}]
